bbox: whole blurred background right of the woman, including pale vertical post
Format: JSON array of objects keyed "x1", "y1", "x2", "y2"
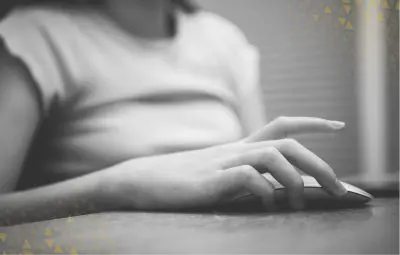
[{"x1": 197, "y1": 0, "x2": 399, "y2": 187}]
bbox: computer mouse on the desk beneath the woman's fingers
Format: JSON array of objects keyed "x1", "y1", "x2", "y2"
[{"x1": 222, "y1": 174, "x2": 373, "y2": 210}]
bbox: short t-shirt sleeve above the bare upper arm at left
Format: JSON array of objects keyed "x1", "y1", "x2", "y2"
[{"x1": 0, "y1": 10, "x2": 63, "y2": 116}]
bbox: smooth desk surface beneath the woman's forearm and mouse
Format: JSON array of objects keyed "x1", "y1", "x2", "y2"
[{"x1": 0, "y1": 198, "x2": 399, "y2": 254}]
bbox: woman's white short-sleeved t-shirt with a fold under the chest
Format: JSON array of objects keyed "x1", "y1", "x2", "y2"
[{"x1": 0, "y1": 4, "x2": 258, "y2": 187}]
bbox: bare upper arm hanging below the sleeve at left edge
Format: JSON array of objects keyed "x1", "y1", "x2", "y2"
[{"x1": 0, "y1": 42, "x2": 40, "y2": 192}]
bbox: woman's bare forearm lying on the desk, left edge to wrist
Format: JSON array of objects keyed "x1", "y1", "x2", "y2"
[{"x1": 0, "y1": 170, "x2": 117, "y2": 226}]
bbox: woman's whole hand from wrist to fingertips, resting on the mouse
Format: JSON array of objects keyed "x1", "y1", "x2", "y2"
[{"x1": 110, "y1": 117, "x2": 346, "y2": 210}]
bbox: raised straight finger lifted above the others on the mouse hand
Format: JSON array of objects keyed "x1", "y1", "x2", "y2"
[{"x1": 243, "y1": 117, "x2": 345, "y2": 142}]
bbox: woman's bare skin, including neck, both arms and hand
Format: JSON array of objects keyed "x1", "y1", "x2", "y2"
[{"x1": 0, "y1": 0, "x2": 346, "y2": 225}]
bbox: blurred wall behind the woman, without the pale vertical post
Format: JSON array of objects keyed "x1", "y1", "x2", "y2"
[{"x1": 198, "y1": 0, "x2": 399, "y2": 176}]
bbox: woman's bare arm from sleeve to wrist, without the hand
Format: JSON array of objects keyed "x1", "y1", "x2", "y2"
[{"x1": 0, "y1": 44, "x2": 117, "y2": 225}]
